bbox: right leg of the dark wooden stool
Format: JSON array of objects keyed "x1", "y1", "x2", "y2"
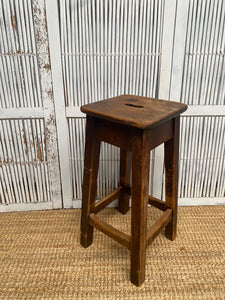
[{"x1": 165, "y1": 117, "x2": 180, "y2": 241}]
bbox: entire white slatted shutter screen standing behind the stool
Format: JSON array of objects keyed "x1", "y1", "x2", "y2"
[{"x1": 0, "y1": 0, "x2": 225, "y2": 211}]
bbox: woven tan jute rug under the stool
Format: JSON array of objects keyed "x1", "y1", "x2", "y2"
[{"x1": 0, "y1": 206, "x2": 225, "y2": 300}]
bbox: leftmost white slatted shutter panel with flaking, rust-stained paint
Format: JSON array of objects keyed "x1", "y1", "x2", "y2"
[{"x1": 0, "y1": 0, "x2": 62, "y2": 211}]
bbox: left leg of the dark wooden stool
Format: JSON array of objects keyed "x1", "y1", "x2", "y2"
[{"x1": 80, "y1": 117, "x2": 100, "y2": 248}]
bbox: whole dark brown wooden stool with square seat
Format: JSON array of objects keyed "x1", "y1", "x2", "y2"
[{"x1": 80, "y1": 95, "x2": 187, "y2": 286}]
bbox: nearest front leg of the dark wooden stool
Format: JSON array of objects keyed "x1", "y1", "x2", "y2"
[{"x1": 130, "y1": 134, "x2": 150, "y2": 286}]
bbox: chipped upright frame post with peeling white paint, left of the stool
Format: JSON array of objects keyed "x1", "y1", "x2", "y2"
[{"x1": 32, "y1": 0, "x2": 62, "y2": 208}]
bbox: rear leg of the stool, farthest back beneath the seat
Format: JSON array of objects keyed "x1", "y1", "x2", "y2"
[{"x1": 118, "y1": 149, "x2": 131, "y2": 215}]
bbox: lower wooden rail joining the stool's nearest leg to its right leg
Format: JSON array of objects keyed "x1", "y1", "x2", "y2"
[{"x1": 146, "y1": 208, "x2": 173, "y2": 247}]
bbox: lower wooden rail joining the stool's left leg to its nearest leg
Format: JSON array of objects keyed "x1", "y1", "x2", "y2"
[{"x1": 89, "y1": 214, "x2": 131, "y2": 249}]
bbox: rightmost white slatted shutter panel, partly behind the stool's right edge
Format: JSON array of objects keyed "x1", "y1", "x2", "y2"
[{"x1": 170, "y1": 0, "x2": 225, "y2": 205}]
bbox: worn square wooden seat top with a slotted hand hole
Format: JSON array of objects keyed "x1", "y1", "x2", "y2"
[{"x1": 81, "y1": 95, "x2": 187, "y2": 129}]
